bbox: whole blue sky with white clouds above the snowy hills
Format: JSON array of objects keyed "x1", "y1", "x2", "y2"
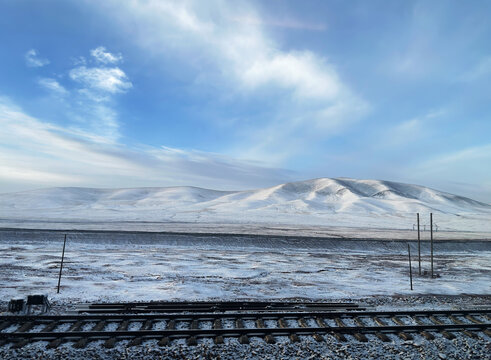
[{"x1": 0, "y1": 0, "x2": 491, "y2": 203}]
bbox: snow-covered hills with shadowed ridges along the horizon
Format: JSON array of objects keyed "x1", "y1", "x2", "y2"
[{"x1": 0, "y1": 178, "x2": 491, "y2": 231}]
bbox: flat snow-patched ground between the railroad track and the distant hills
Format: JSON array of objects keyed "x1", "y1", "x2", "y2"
[{"x1": 0, "y1": 230, "x2": 491, "y2": 302}]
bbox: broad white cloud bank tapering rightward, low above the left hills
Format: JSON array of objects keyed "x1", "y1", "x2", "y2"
[{"x1": 0, "y1": 98, "x2": 287, "y2": 191}]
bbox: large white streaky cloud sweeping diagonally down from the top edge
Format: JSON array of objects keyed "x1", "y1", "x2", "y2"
[{"x1": 87, "y1": 0, "x2": 370, "y2": 161}]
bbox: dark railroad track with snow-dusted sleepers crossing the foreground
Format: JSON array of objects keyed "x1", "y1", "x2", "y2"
[{"x1": 0, "y1": 308, "x2": 491, "y2": 348}]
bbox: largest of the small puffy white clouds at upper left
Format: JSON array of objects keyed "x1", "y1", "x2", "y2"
[{"x1": 70, "y1": 66, "x2": 133, "y2": 94}]
